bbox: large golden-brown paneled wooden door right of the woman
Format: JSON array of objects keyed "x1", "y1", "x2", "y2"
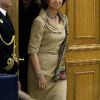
[{"x1": 62, "y1": 0, "x2": 100, "y2": 100}]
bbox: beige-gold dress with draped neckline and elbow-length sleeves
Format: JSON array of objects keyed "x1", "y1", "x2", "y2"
[{"x1": 28, "y1": 10, "x2": 67, "y2": 100}]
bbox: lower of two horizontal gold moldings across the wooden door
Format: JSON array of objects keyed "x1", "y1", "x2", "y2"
[{"x1": 66, "y1": 59, "x2": 100, "y2": 66}]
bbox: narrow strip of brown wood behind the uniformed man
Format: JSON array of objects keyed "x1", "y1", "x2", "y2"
[{"x1": 8, "y1": 0, "x2": 18, "y2": 56}]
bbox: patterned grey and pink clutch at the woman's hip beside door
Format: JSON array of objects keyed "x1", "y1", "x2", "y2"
[{"x1": 53, "y1": 66, "x2": 66, "y2": 82}]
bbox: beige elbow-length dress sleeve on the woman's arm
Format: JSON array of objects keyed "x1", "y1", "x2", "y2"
[{"x1": 28, "y1": 19, "x2": 44, "y2": 54}]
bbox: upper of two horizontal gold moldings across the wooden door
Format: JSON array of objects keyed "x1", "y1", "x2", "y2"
[{"x1": 68, "y1": 44, "x2": 100, "y2": 51}]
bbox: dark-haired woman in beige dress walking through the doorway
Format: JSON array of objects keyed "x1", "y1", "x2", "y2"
[{"x1": 28, "y1": 0, "x2": 67, "y2": 100}]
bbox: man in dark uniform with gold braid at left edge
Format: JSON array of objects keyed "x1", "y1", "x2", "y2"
[{"x1": 0, "y1": 0, "x2": 18, "y2": 74}]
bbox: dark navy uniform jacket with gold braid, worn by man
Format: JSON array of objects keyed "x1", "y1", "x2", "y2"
[{"x1": 0, "y1": 12, "x2": 18, "y2": 74}]
